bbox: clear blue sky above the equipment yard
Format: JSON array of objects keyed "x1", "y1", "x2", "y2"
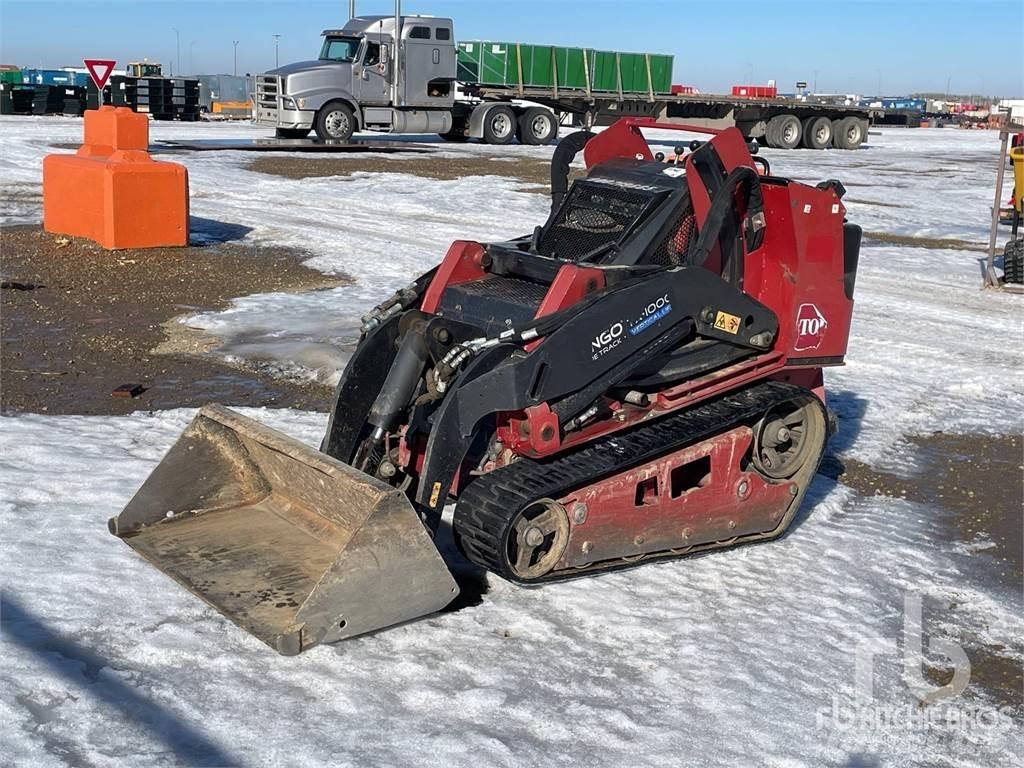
[{"x1": 0, "y1": 0, "x2": 1024, "y2": 97}]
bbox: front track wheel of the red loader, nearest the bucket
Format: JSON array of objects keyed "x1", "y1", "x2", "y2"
[{"x1": 503, "y1": 499, "x2": 569, "y2": 582}]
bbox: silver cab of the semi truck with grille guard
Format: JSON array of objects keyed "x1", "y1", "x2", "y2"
[{"x1": 254, "y1": 15, "x2": 456, "y2": 141}]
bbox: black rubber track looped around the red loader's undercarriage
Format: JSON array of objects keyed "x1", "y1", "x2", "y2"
[{"x1": 453, "y1": 381, "x2": 813, "y2": 584}]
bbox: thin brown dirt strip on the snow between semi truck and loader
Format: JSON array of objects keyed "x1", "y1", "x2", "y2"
[{"x1": 249, "y1": 155, "x2": 569, "y2": 193}]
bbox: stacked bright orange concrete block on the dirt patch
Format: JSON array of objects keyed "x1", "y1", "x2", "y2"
[{"x1": 43, "y1": 106, "x2": 188, "y2": 249}]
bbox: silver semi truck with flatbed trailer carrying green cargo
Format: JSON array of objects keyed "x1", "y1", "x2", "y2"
[{"x1": 253, "y1": 7, "x2": 882, "y2": 150}]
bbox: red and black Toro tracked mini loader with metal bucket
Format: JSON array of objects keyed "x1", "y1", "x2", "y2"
[{"x1": 111, "y1": 119, "x2": 860, "y2": 654}]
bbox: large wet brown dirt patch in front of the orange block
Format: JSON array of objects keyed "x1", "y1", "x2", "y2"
[{"x1": 0, "y1": 226, "x2": 347, "y2": 415}]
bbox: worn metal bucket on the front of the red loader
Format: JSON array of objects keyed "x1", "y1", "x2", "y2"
[{"x1": 110, "y1": 406, "x2": 459, "y2": 655}]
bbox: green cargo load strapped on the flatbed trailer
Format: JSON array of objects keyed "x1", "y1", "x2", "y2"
[{"x1": 458, "y1": 40, "x2": 672, "y2": 95}]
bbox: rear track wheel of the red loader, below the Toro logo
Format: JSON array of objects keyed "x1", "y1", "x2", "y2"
[{"x1": 753, "y1": 399, "x2": 827, "y2": 480}]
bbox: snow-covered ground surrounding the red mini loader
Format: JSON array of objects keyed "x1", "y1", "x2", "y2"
[{"x1": 0, "y1": 118, "x2": 1024, "y2": 768}]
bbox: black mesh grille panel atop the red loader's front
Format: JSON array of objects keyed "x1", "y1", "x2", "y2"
[{"x1": 538, "y1": 180, "x2": 655, "y2": 261}]
